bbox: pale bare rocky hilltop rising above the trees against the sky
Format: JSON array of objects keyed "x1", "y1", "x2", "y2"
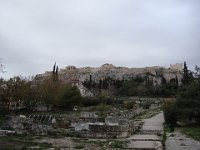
[{"x1": 35, "y1": 64, "x2": 183, "y2": 84}]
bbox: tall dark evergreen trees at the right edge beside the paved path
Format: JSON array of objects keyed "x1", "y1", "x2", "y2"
[{"x1": 163, "y1": 63, "x2": 200, "y2": 126}]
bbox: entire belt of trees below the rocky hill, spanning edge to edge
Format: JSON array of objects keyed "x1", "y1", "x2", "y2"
[{"x1": 0, "y1": 62, "x2": 200, "y2": 124}]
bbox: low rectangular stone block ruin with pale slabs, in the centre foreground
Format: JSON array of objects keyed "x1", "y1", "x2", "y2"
[{"x1": 71, "y1": 112, "x2": 129, "y2": 138}]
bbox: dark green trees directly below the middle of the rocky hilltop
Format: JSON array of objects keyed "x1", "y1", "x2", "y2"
[{"x1": 82, "y1": 72, "x2": 178, "y2": 97}]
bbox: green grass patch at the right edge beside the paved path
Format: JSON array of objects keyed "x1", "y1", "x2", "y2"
[{"x1": 180, "y1": 126, "x2": 200, "y2": 141}]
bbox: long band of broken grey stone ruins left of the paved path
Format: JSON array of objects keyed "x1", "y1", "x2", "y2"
[{"x1": 0, "y1": 98, "x2": 162, "y2": 138}]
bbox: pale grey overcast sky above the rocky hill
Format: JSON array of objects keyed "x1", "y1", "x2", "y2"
[{"x1": 0, "y1": 0, "x2": 200, "y2": 78}]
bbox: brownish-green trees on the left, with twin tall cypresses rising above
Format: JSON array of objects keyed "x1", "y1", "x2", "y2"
[{"x1": 0, "y1": 65, "x2": 82, "y2": 115}]
